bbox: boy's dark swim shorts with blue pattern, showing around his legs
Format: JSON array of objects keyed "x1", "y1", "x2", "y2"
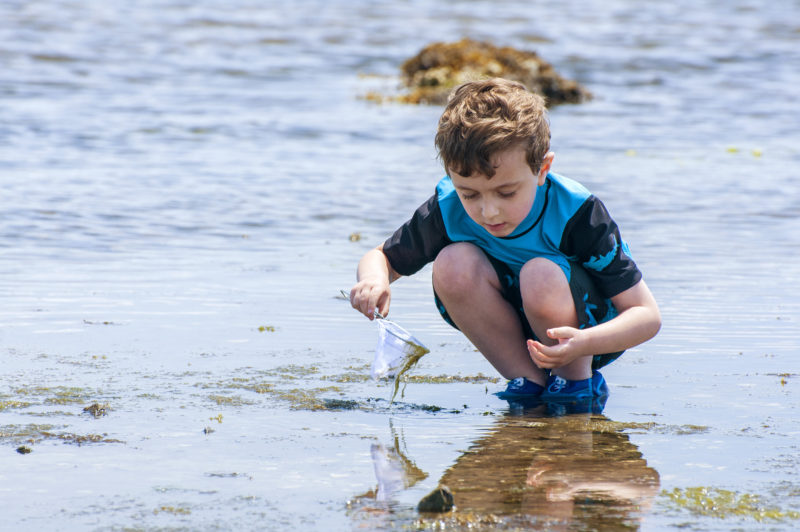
[{"x1": 433, "y1": 252, "x2": 623, "y2": 369}]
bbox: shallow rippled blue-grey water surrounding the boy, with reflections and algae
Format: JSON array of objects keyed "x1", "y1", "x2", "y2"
[{"x1": 0, "y1": 0, "x2": 800, "y2": 530}]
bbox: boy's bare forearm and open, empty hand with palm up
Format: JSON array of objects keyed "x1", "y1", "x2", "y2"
[{"x1": 528, "y1": 280, "x2": 661, "y2": 368}]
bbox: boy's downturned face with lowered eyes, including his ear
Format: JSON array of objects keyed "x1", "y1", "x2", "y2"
[{"x1": 450, "y1": 146, "x2": 553, "y2": 236}]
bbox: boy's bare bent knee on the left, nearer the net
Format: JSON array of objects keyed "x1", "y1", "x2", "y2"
[{"x1": 433, "y1": 242, "x2": 488, "y2": 294}]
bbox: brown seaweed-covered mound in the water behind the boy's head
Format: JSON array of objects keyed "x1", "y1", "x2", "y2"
[{"x1": 384, "y1": 39, "x2": 591, "y2": 106}]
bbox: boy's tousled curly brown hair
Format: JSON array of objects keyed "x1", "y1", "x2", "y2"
[{"x1": 435, "y1": 78, "x2": 550, "y2": 178}]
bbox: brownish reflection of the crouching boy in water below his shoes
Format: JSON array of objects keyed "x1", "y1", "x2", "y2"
[{"x1": 441, "y1": 410, "x2": 659, "y2": 530}]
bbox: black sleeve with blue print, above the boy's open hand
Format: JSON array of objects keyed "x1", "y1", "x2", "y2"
[{"x1": 560, "y1": 196, "x2": 642, "y2": 297}]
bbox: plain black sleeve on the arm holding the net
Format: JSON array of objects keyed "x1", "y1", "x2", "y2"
[{"x1": 383, "y1": 194, "x2": 451, "y2": 275}]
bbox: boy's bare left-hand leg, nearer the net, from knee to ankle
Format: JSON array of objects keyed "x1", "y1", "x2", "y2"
[{"x1": 433, "y1": 242, "x2": 552, "y2": 385}]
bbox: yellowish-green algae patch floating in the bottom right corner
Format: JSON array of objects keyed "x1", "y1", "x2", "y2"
[{"x1": 661, "y1": 487, "x2": 800, "y2": 522}]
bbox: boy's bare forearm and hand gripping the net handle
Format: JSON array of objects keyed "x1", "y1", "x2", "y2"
[{"x1": 350, "y1": 244, "x2": 401, "y2": 320}]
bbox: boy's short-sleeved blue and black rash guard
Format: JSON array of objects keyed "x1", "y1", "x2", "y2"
[{"x1": 383, "y1": 173, "x2": 642, "y2": 298}]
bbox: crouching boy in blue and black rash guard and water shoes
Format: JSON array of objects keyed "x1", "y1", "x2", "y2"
[{"x1": 350, "y1": 79, "x2": 661, "y2": 402}]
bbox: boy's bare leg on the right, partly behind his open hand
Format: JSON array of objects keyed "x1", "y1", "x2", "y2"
[{"x1": 519, "y1": 257, "x2": 592, "y2": 380}]
